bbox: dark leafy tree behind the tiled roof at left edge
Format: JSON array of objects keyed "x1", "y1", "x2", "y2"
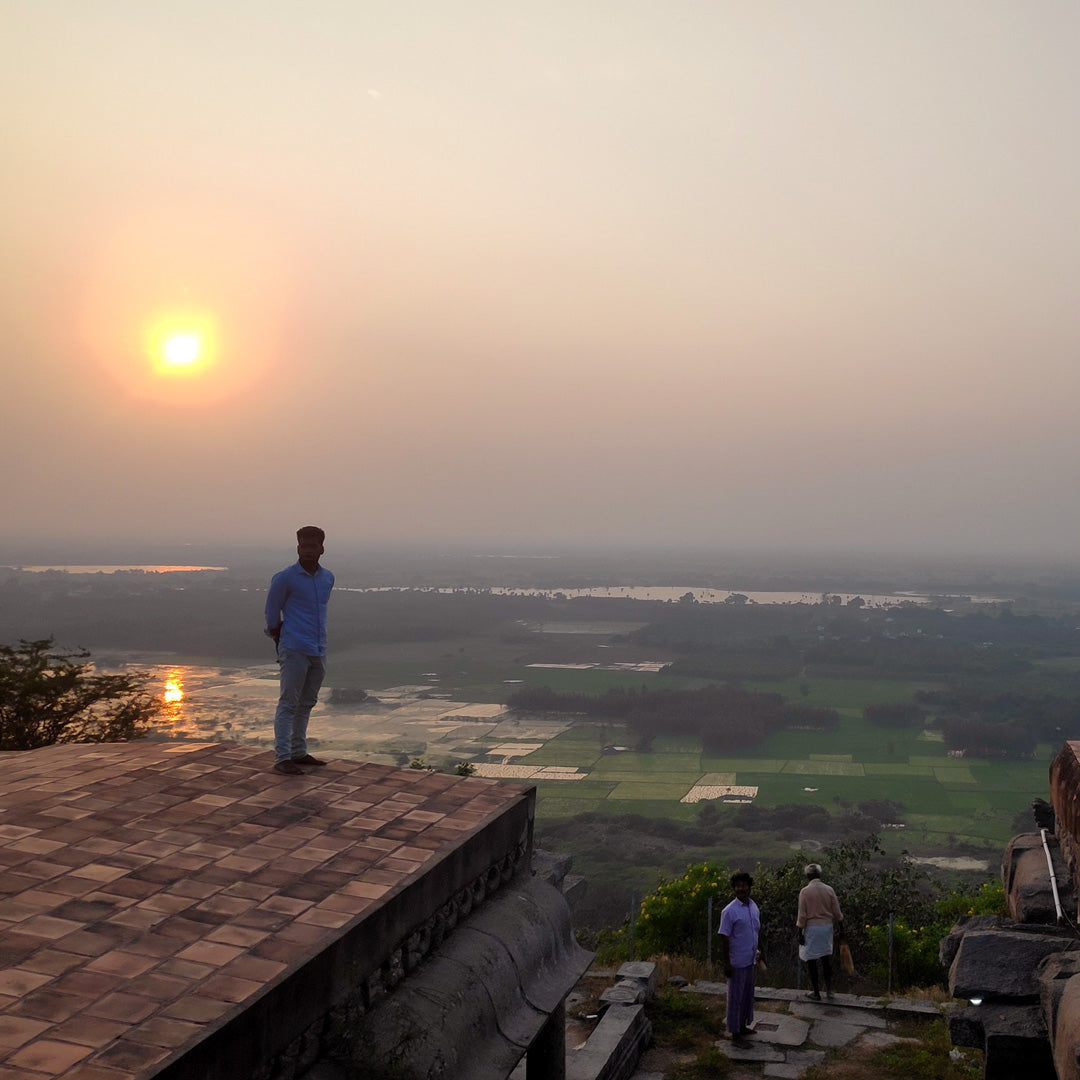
[{"x1": 0, "y1": 637, "x2": 161, "y2": 751}]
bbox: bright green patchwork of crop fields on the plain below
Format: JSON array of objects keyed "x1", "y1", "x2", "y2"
[{"x1": 498, "y1": 679, "x2": 1053, "y2": 852}]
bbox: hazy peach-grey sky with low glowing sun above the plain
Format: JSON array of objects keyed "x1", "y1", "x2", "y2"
[{"x1": 0, "y1": 0, "x2": 1080, "y2": 553}]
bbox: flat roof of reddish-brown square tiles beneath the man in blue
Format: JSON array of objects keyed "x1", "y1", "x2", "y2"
[{"x1": 0, "y1": 742, "x2": 532, "y2": 1080}]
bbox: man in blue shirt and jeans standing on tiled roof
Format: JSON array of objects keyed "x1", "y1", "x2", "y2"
[{"x1": 266, "y1": 525, "x2": 334, "y2": 775}]
